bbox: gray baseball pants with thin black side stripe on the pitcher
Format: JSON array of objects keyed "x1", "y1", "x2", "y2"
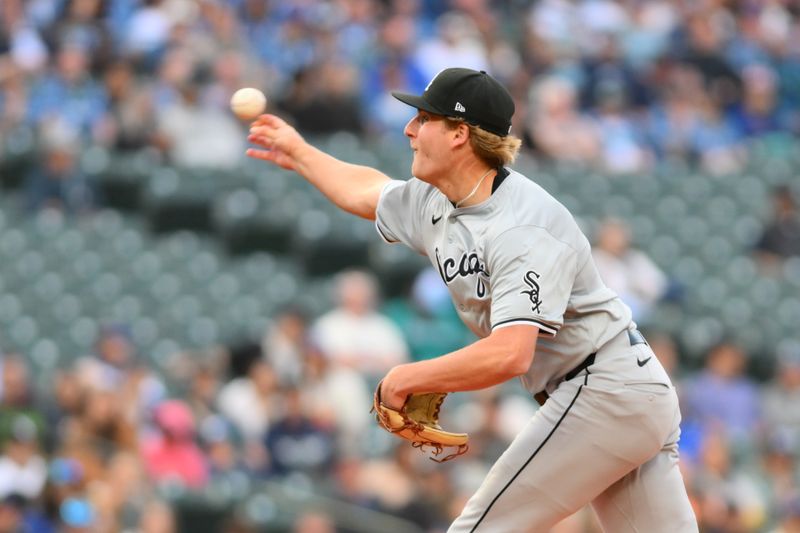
[{"x1": 448, "y1": 332, "x2": 698, "y2": 533}]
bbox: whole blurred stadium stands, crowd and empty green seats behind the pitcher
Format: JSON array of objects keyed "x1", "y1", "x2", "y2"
[{"x1": 0, "y1": 0, "x2": 800, "y2": 533}]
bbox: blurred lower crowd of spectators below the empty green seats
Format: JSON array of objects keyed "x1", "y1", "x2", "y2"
[{"x1": 0, "y1": 271, "x2": 800, "y2": 533}]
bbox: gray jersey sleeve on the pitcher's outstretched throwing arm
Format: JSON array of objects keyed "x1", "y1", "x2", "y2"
[{"x1": 375, "y1": 180, "x2": 425, "y2": 254}]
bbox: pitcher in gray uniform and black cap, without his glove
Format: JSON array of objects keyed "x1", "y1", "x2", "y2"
[{"x1": 247, "y1": 68, "x2": 698, "y2": 533}]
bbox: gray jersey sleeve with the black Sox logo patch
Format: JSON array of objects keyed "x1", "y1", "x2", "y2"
[{"x1": 487, "y1": 226, "x2": 578, "y2": 336}]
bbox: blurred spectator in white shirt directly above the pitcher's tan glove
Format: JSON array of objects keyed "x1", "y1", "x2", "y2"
[{"x1": 311, "y1": 272, "x2": 408, "y2": 378}]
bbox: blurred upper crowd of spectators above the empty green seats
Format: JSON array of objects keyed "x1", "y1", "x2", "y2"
[{"x1": 0, "y1": 0, "x2": 800, "y2": 198}]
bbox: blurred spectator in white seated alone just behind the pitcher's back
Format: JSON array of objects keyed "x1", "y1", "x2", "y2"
[{"x1": 592, "y1": 219, "x2": 669, "y2": 322}]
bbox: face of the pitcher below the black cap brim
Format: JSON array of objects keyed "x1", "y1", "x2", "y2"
[{"x1": 403, "y1": 110, "x2": 457, "y2": 183}]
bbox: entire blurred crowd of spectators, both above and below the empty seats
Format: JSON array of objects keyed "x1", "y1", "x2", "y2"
[{"x1": 0, "y1": 0, "x2": 800, "y2": 533}]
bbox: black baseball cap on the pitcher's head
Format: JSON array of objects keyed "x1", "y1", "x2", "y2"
[{"x1": 392, "y1": 68, "x2": 514, "y2": 137}]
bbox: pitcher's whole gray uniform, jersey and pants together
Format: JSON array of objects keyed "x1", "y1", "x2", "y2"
[{"x1": 376, "y1": 169, "x2": 698, "y2": 533}]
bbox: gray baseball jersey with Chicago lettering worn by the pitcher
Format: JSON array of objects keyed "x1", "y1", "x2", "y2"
[{"x1": 376, "y1": 169, "x2": 631, "y2": 393}]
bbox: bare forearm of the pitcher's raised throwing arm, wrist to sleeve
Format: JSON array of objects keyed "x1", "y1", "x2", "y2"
[{"x1": 295, "y1": 144, "x2": 390, "y2": 220}]
